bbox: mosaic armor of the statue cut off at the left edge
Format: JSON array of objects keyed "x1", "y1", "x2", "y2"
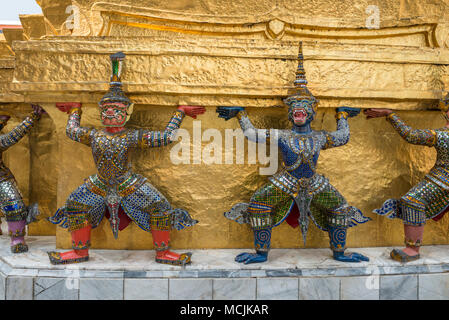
[{"x1": 0, "y1": 115, "x2": 37, "y2": 221}]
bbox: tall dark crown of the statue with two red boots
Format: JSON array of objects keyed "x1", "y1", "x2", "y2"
[{"x1": 99, "y1": 52, "x2": 132, "y2": 106}]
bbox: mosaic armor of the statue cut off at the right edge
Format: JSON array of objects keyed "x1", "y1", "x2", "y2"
[{"x1": 374, "y1": 113, "x2": 449, "y2": 226}]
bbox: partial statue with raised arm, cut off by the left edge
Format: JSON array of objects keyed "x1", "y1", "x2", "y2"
[{"x1": 0, "y1": 105, "x2": 44, "y2": 253}]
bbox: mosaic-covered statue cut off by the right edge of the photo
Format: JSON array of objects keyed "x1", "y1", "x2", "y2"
[{"x1": 365, "y1": 94, "x2": 449, "y2": 262}]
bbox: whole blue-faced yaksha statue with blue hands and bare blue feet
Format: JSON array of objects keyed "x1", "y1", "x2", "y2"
[{"x1": 217, "y1": 43, "x2": 370, "y2": 264}]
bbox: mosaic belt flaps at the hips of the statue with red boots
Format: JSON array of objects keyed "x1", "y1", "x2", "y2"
[{"x1": 86, "y1": 173, "x2": 146, "y2": 197}]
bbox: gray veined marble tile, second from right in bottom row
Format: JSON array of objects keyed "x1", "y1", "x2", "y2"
[{"x1": 380, "y1": 275, "x2": 418, "y2": 300}]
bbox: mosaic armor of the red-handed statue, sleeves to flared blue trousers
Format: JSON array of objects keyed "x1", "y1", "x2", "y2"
[{"x1": 50, "y1": 109, "x2": 196, "y2": 236}]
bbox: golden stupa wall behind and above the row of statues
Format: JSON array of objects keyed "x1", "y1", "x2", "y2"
[{"x1": 0, "y1": 0, "x2": 449, "y2": 249}]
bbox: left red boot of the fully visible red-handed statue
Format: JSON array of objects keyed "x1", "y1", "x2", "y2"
[{"x1": 48, "y1": 225, "x2": 92, "y2": 264}]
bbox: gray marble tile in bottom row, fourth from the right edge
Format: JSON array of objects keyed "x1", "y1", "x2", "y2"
[{"x1": 299, "y1": 277, "x2": 340, "y2": 300}]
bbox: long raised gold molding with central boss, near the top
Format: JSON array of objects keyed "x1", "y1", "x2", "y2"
[{"x1": 99, "y1": 11, "x2": 439, "y2": 48}]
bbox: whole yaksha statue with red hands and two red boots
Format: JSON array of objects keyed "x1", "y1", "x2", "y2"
[{"x1": 48, "y1": 52, "x2": 205, "y2": 265}]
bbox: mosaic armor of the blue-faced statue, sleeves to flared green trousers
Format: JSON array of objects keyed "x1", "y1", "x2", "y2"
[{"x1": 228, "y1": 111, "x2": 369, "y2": 245}]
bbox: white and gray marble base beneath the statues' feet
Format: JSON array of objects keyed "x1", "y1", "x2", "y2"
[{"x1": 0, "y1": 236, "x2": 449, "y2": 300}]
